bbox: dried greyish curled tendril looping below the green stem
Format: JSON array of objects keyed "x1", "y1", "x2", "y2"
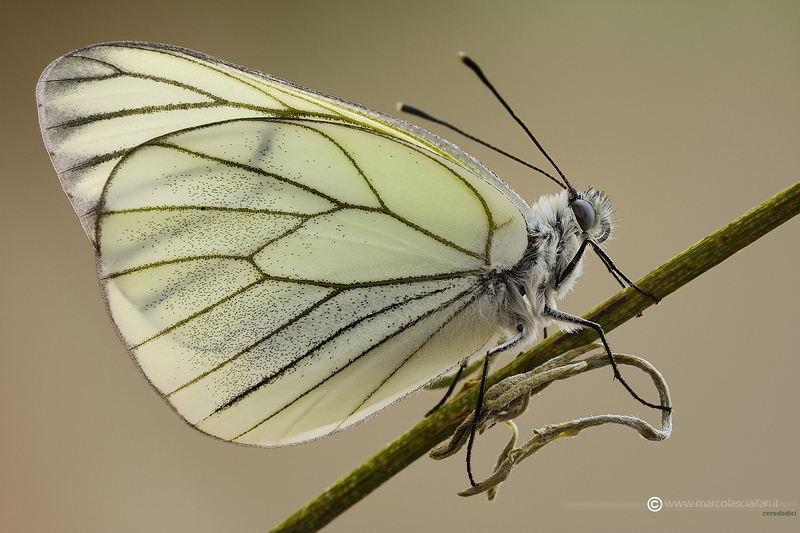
[{"x1": 430, "y1": 344, "x2": 672, "y2": 500}]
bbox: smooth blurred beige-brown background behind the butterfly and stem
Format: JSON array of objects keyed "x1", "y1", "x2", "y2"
[{"x1": 0, "y1": 0, "x2": 800, "y2": 532}]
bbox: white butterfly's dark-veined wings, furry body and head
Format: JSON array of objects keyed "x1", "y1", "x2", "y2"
[{"x1": 37, "y1": 42, "x2": 656, "y2": 446}]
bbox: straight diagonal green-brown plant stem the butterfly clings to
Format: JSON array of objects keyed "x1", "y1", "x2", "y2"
[{"x1": 272, "y1": 183, "x2": 800, "y2": 533}]
